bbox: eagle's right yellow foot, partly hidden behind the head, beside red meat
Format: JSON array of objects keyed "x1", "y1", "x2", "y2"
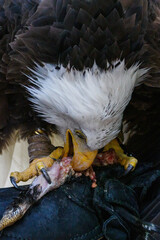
[{"x1": 96, "y1": 139, "x2": 138, "y2": 174}]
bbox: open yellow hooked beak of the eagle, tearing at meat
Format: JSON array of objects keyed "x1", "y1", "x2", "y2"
[{"x1": 63, "y1": 129, "x2": 98, "y2": 171}]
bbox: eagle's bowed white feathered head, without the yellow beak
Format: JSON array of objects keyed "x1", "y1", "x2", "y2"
[{"x1": 28, "y1": 61, "x2": 147, "y2": 150}]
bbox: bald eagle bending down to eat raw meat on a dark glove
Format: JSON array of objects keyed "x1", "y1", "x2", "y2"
[{"x1": 0, "y1": 0, "x2": 160, "y2": 206}]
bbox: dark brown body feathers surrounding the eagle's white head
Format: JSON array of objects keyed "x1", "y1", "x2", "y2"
[{"x1": 0, "y1": 0, "x2": 160, "y2": 155}]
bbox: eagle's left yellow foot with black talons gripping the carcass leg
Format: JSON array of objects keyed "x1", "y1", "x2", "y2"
[{"x1": 10, "y1": 147, "x2": 63, "y2": 190}]
